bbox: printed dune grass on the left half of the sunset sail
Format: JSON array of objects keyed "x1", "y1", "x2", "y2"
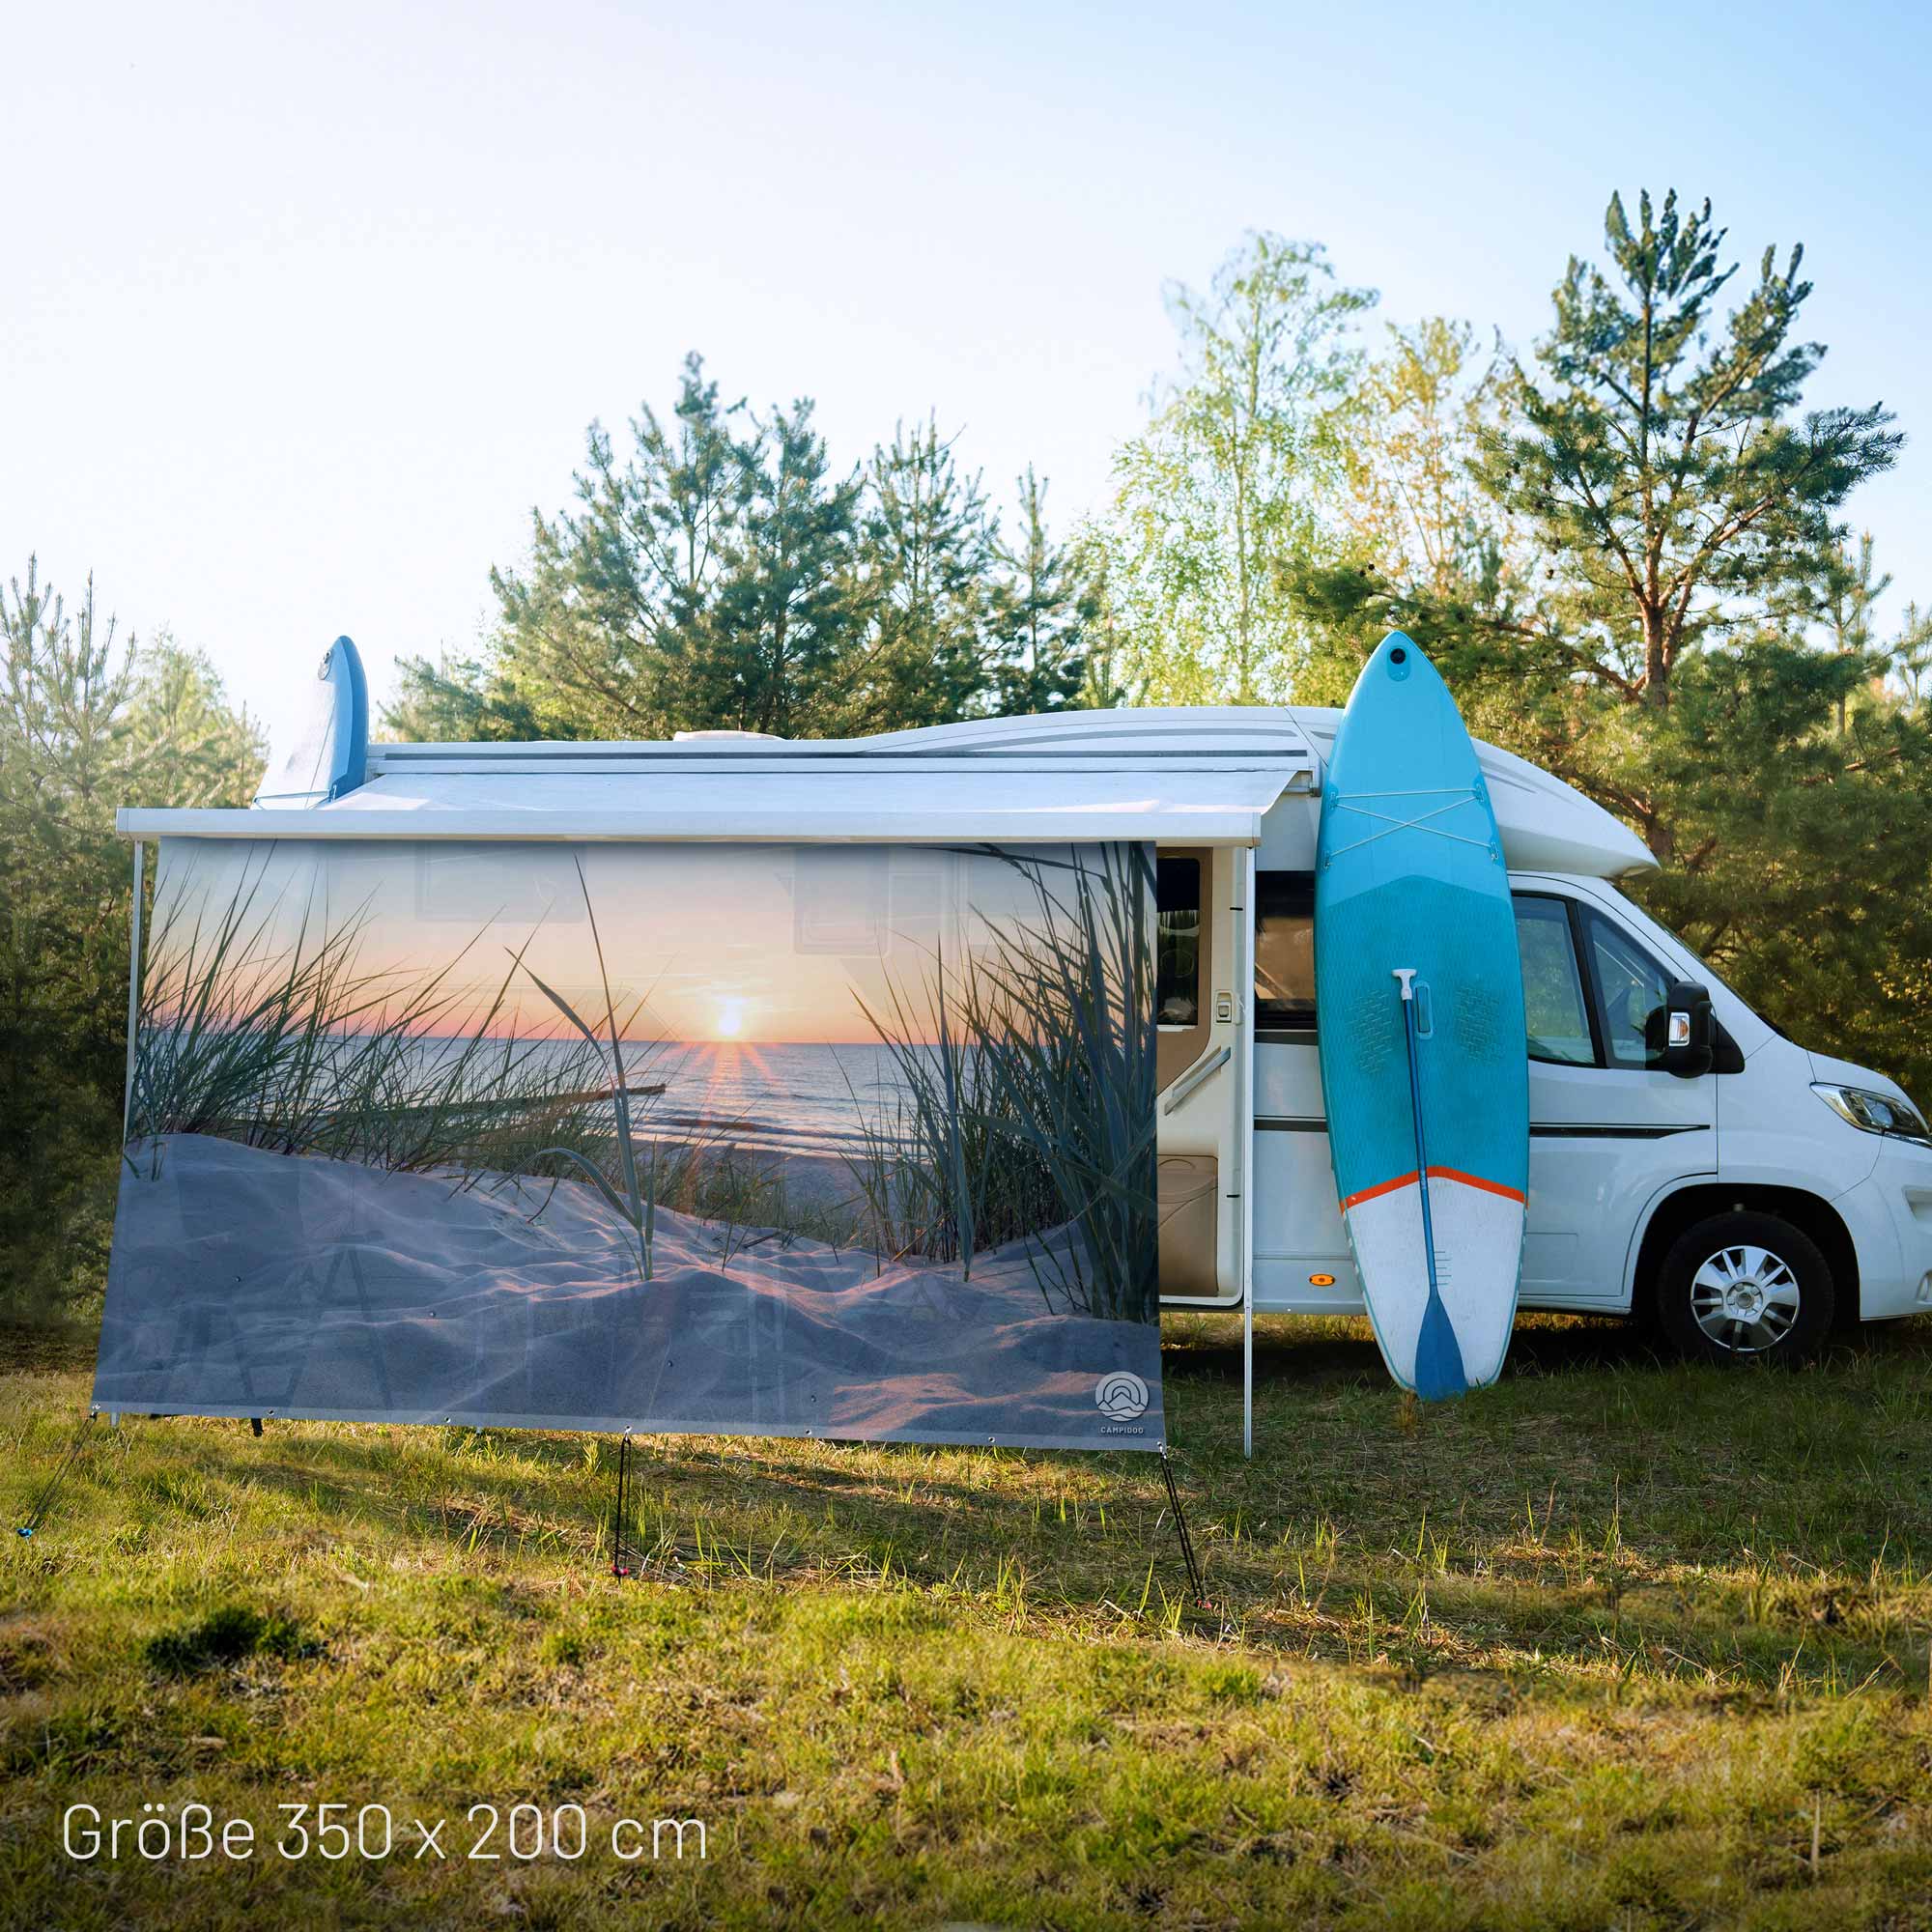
[{"x1": 128, "y1": 864, "x2": 815, "y2": 1279}]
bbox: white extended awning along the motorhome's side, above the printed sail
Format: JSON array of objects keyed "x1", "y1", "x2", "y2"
[{"x1": 118, "y1": 757, "x2": 1312, "y2": 846}]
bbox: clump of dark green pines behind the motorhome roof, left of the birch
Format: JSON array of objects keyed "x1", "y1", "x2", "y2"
[{"x1": 384, "y1": 355, "x2": 1078, "y2": 738}]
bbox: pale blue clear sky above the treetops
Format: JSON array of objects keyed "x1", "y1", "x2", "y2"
[{"x1": 0, "y1": 0, "x2": 1932, "y2": 753}]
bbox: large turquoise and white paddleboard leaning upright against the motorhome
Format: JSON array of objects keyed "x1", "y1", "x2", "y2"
[{"x1": 1316, "y1": 632, "x2": 1530, "y2": 1401}]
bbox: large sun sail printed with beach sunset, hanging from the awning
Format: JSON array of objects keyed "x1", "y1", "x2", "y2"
[{"x1": 95, "y1": 840, "x2": 1163, "y2": 1449}]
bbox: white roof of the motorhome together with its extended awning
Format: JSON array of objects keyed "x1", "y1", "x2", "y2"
[{"x1": 120, "y1": 705, "x2": 1654, "y2": 877}]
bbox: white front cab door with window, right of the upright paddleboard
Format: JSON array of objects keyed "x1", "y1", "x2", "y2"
[{"x1": 1515, "y1": 889, "x2": 1718, "y2": 1308}]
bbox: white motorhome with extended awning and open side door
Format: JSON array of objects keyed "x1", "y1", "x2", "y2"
[{"x1": 122, "y1": 707, "x2": 1932, "y2": 1383}]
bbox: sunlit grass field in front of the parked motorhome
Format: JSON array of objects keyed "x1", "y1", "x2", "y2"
[{"x1": 0, "y1": 1318, "x2": 1932, "y2": 1932}]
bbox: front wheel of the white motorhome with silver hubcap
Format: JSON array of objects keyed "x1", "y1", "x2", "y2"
[{"x1": 1658, "y1": 1209, "x2": 1833, "y2": 1362}]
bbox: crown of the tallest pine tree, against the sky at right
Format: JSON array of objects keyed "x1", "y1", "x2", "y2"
[{"x1": 1488, "y1": 191, "x2": 1903, "y2": 711}]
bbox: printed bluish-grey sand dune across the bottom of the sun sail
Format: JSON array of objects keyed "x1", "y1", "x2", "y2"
[{"x1": 95, "y1": 1134, "x2": 1161, "y2": 1447}]
